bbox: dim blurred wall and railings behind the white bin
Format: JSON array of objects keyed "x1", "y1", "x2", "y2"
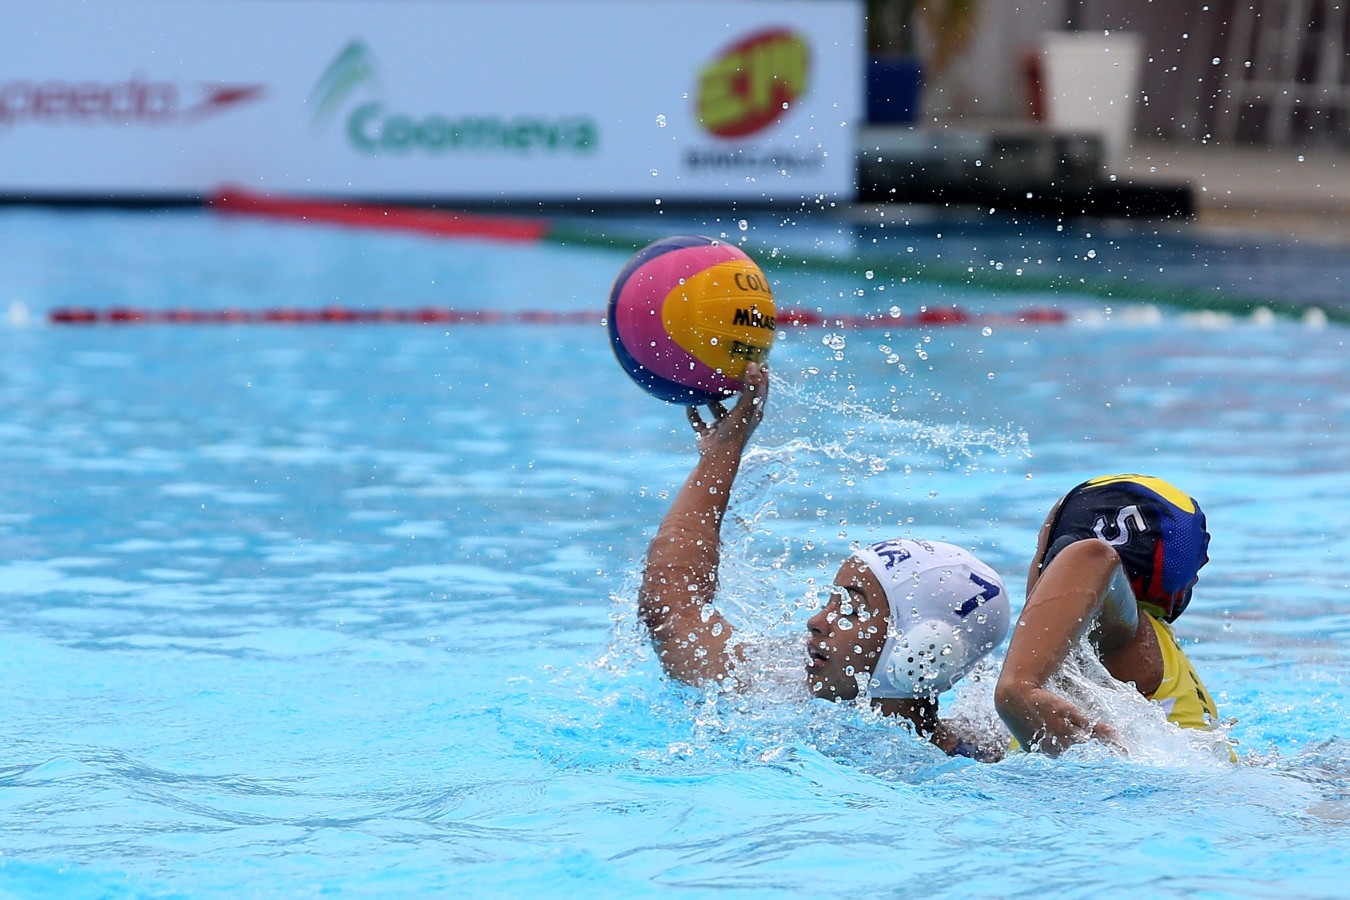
[{"x1": 919, "y1": 0, "x2": 1350, "y2": 147}]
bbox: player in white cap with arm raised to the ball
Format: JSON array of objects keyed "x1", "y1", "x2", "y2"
[{"x1": 639, "y1": 363, "x2": 1010, "y2": 758}]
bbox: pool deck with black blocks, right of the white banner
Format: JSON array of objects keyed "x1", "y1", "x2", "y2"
[{"x1": 859, "y1": 121, "x2": 1350, "y2": 244}]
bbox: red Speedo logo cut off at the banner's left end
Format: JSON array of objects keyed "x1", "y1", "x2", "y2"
[{"x1": 0, "y1": 76, "x2": 263, "y2": 125}]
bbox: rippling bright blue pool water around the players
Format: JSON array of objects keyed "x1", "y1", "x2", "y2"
[{"x1": 0, "y1": 209, "x2": 1350, "y2": 897}]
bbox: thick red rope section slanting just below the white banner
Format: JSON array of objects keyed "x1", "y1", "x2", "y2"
[{"x1": 208, "y1": 188, "x2": 548, "y2": 242}]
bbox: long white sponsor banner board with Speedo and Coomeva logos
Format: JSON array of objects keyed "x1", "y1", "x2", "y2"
[{"x1": 0, "y1": 0, "x2": 864, "y2": 202}]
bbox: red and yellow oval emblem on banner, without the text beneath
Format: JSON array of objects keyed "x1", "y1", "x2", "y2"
[{"x1": 697, "y1": 28, "x2": 811, "y2": 138}]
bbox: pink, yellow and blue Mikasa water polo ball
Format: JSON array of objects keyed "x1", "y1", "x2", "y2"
[{"x1": 608, "y1": 235, "x2": 775, "y2": 406}]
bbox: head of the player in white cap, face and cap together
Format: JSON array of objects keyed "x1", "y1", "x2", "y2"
[{"x1": 807, "y1": 540, "x2": 1011, "y2": 700}]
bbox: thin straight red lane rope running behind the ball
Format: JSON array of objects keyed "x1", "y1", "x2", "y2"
[{"x1": 47, "y1": 306, "x2": 1068, "y2": 328}]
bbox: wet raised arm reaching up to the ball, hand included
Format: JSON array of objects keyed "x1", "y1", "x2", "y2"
[{"x1": 637, "y1": 363, "x2": 768, "y2": 684}]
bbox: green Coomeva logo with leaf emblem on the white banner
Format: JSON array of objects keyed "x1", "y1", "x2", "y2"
[{"x1": 309, "y1": 40, "x2": 599, "y2": 155}]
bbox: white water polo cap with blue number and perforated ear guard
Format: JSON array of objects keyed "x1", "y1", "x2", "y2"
[{"x1": 853, "y1": 540, "x2": 1011, "y2": 699}]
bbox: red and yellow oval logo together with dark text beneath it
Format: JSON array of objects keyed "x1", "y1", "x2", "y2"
[{"x1": 684, "y1": 28, "x2": 825, "y2": 177}]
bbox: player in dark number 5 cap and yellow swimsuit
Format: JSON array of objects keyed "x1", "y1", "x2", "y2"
[{"x1": 994, "y1": 475, "x2": 1231, "y2": 756}]
